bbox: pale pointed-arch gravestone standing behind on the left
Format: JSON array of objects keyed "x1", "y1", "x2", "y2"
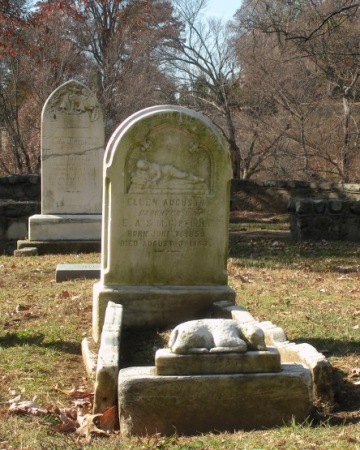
[{"x1": 29, "y1": 80, "x2": 105, "y2": 241}]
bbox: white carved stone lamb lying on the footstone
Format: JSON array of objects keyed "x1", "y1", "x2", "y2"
[{"x1": 169, "y1": 319, "x2": 266, "y2": 354}]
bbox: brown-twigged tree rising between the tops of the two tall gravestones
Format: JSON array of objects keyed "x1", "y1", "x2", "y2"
[{"x1": 61, "y1": 0, "x2": 179, "y2": 136}]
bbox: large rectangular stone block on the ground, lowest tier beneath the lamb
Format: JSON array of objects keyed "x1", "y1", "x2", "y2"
[{"x1": 118, "y1": 364, "x2": 312, "y2": 436}]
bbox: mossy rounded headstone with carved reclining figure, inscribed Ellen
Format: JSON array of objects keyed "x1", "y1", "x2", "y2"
[{"x1": 93, "y1": 106, "x2": 235, "y2": 341}]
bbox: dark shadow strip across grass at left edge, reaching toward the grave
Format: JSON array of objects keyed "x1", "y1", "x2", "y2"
[{"x1": 0, "y1": 332, "x2": 81, "y2": 355}]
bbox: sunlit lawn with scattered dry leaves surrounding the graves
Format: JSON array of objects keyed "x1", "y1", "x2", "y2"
[{"x1": 0, "y1": 217, "x2": 360, "y2": 450}]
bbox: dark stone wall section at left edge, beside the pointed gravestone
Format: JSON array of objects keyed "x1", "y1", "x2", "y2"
[{"x1": 0, "y1": 175, "x2": 40, "y2": 254}]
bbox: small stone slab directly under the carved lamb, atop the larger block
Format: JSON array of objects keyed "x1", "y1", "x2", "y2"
[{"x1": 155, "y1": 347, "x2": 281, "y2": 375}]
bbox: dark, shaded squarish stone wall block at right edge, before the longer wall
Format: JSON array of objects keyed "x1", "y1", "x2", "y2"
[{"x1": 289, "y1": 198, "x2": 360, "y2": 241}]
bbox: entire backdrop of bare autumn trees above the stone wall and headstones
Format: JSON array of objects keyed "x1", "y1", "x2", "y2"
[{"x1": 0, "y1": 0, "x2": 360, "y2": 182}]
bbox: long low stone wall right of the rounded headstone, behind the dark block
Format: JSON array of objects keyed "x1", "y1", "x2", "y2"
[{"x1": 231, "y1": 180, "x2": 360, "y2": 214}]
